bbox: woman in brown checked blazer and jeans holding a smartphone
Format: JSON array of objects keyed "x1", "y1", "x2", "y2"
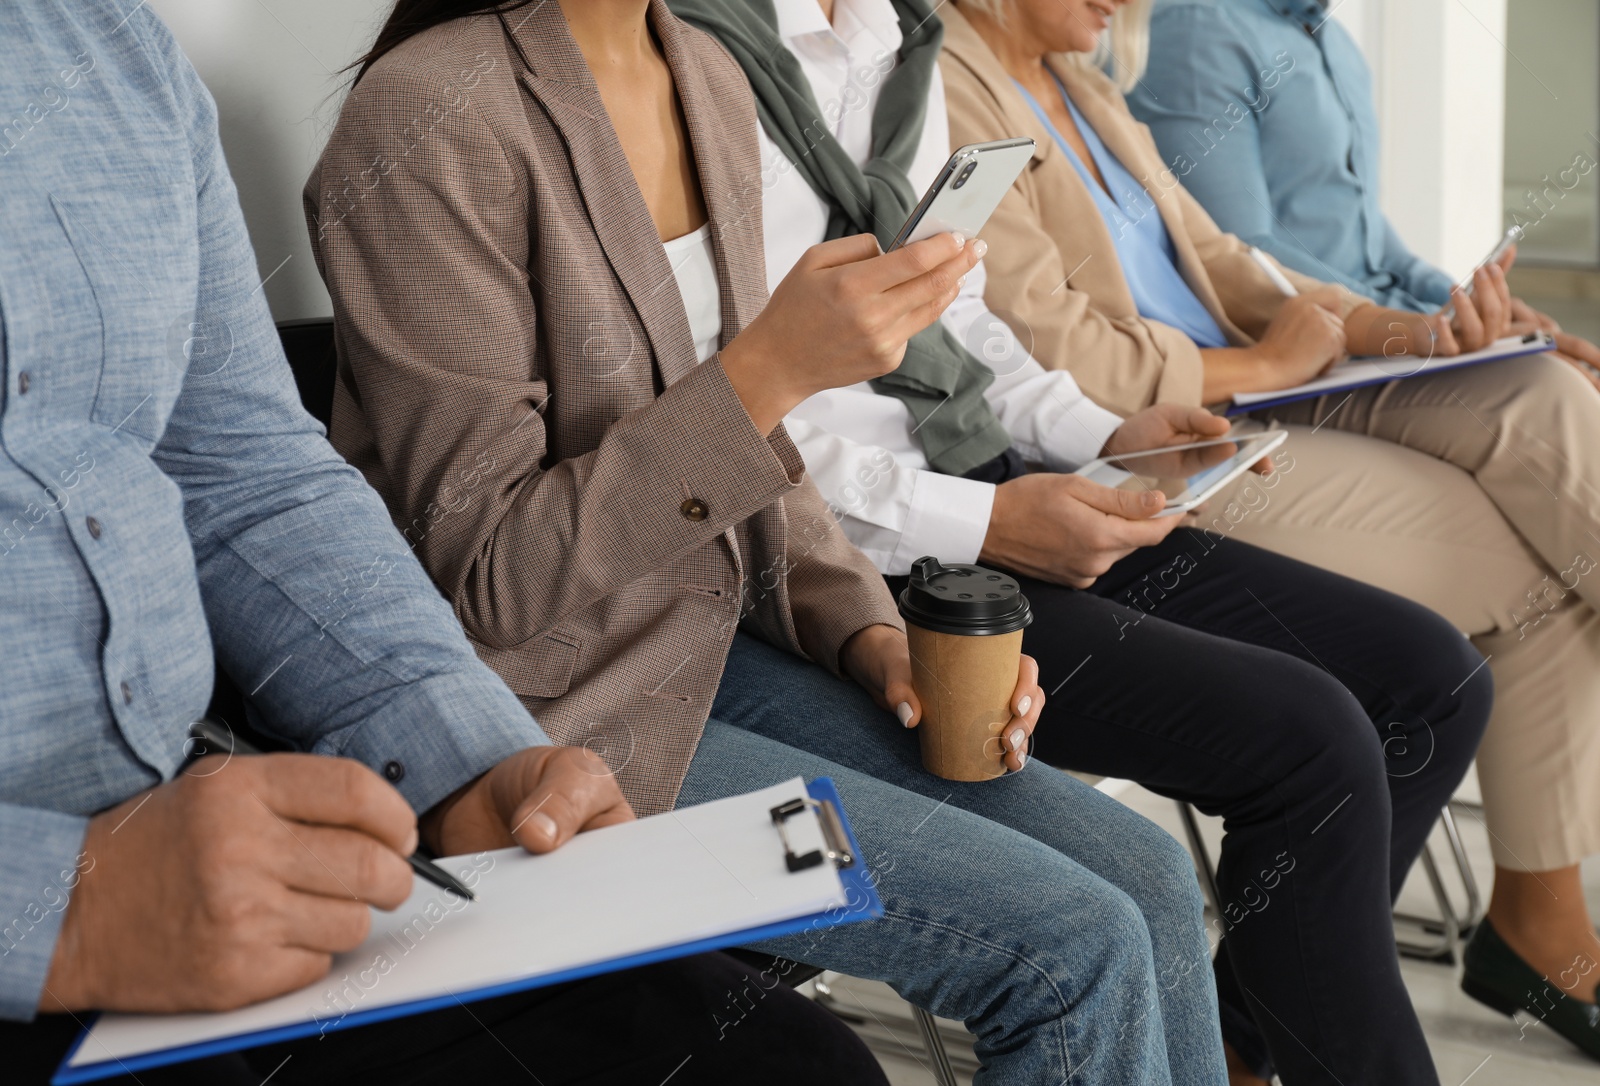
[{"x1": 306, "y1": 0, "x2": 1222, "y2": 1086}]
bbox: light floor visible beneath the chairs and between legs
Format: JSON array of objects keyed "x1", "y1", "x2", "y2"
[{"x1": 830, "y1": 785, "x2": 1600, "y2": 1086}]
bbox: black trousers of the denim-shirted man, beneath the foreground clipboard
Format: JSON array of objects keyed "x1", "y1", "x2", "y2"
[{"x1": 0, "y1": 955, "x2": 888, "y2": 1086}]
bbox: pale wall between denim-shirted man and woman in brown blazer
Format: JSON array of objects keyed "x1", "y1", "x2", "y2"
[{"x1": 147, "y1": 0, "x2": 392, "y2": 320}]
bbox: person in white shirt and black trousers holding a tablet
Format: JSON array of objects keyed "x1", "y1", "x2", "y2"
[{"x1": 670, "y1": 0, "x2": 1490, "y2": 1086}]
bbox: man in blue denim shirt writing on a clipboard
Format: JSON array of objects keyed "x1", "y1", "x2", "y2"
[{"x1": 0, "y1": 0, "x2": 883, "y2": 1083}]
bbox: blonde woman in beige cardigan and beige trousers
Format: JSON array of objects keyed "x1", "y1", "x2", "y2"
[{"x1": 942, "y1": 0, "x2": 1600, "y2": 1074}]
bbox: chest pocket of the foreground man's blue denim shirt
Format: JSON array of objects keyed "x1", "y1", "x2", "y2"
[{"x1": 50, "y1": 181, "x2": 200, "y2": 443}]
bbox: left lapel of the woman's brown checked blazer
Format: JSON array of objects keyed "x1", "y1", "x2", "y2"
[{"x1": 507, "y1": 3, "x2": 697, "y2": 387}]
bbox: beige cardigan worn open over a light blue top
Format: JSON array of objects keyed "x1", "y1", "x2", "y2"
[{"x1": 939, "y1": 5, "x2": 1370, "y2": 414}]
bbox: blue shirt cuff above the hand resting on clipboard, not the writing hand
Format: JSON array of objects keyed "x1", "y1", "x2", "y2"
[{"x1": 318, "y1": 667, "x2": 550, "y2": 814}]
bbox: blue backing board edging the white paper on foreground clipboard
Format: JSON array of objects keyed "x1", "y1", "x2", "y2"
[{"x1": 50, "y1": 777, "x2": 883, "y2": 1086}]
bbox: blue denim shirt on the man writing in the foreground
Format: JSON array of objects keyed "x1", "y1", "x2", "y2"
[{"x1": 0, "y1": 0, "x2": 547, "y2": 1019}]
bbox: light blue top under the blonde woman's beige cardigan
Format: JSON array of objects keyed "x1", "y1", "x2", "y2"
[{"x1": 1016, "y1": 80, "x2": 1227, "y2": 347}]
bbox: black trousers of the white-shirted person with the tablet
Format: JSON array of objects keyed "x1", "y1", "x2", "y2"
[{"x1": 890, "y1": 529, "x2": 1491, "y2": 1086}]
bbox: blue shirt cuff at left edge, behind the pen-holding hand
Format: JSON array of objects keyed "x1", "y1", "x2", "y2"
[{"x1": 0, "y1": 803, "x2": 90, "y2": 1022}]
